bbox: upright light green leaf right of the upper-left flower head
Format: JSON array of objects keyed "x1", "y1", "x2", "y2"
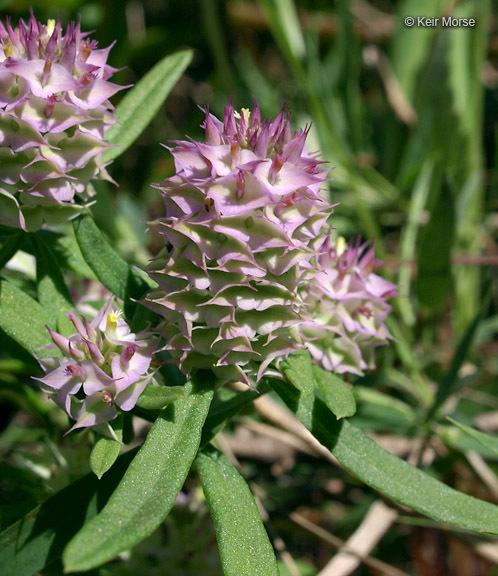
[{"x1": 102, "y1": 50, "x2": 192, "y2": 162}]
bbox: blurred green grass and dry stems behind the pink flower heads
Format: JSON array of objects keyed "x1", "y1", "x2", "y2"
[{"x1": 0, "y1": 0, "x2": 498, "y2": 576}]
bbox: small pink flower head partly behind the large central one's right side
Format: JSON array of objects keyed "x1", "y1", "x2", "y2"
[{"x1": 297, "y1": 238, "x2": 397, "y2": 374}]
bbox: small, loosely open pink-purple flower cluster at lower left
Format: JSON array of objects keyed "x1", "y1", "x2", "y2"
[{"x1": 37, "y1": 298, "x2": 158, "y2": 437}]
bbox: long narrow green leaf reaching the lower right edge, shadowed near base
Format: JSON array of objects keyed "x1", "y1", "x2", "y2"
[{"x1": 271, "y1": 379, "x2": 498, "y2": 534}]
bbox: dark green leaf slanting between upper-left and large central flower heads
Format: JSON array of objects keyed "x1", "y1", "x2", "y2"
[{"x1": 74, "y1": 209, "x2": 149, "y2": 300}]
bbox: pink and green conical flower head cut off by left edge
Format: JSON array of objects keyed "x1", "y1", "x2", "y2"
[{"x1": 0, "y1": 14, "x2": 121, "y2": 229}]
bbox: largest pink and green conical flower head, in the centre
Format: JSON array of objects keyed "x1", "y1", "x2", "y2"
[{"x1": 149, "y1": 104, "x2": 331, "y2": 383}]
